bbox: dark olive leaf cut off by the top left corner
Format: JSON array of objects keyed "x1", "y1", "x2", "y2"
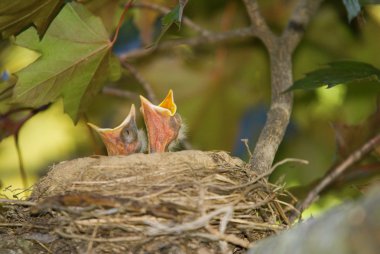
[{"x1": 0, "y1": 0, "x2": 63, "y2": 38}]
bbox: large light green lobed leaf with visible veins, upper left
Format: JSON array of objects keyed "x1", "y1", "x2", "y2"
[{"x1": 13, "y1": 3, "x2": 120, "y2": 122}]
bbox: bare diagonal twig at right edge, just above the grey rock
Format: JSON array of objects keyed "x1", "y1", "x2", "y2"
[{"x1": 298, "y1": 134, "x2": 380, "y2": 212}]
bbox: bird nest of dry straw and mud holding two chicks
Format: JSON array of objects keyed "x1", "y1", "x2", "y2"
[{"x1": 0, "y1": 151, "x2": 293, "y2": 253}]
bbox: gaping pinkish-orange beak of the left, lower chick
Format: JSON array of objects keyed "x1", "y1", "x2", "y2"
[{"x1": 87, "y1": 104, "x2": 142, "y2": 155}]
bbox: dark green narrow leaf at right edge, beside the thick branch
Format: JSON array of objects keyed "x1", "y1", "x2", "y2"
[{"x1": 287, "y1": 61, "x2": 380, "y2": 91}]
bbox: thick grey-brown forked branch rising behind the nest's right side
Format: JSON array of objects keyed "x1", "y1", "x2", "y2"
[{"x1": 249, "y1": 0, "x2": 322, "y2": 174}]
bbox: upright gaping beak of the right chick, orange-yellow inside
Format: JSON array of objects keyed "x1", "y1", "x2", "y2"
[{"x1": 140, "y1": 90, "x2": 181, "y2": 153}]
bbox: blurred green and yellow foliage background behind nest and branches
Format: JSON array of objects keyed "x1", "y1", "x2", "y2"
[{"x1": 0, "y1": 0, "x2": 380, "y2": 214}]
